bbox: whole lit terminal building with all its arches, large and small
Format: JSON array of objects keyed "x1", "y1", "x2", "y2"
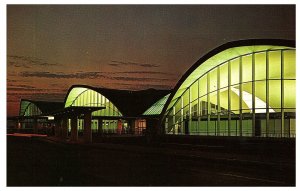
[{"x1": 9, "y1": 39, "x2": 296, "y2": 140}]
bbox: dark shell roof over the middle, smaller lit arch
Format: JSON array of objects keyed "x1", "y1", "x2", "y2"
[{"x1": 64, "y1": 85, "x2": 170, "y2": 117}]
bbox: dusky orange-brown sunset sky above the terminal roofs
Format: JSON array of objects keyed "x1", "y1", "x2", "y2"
[{"x1": 7, "y1": 5, "x2": 295, "y2": 116}]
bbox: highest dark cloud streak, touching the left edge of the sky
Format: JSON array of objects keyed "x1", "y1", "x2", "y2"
[{"x1": 8, "y1": 55, "x2": 58, "y2": 68}]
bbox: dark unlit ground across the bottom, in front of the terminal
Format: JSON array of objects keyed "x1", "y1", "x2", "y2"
[{"x1": 7, "y1": 136, "x2": 295, "y2": 186}]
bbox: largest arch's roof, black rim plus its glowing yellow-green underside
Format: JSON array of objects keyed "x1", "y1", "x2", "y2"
[{"x1": 161, "y1": 39, "x2": 296, "y2": 119}]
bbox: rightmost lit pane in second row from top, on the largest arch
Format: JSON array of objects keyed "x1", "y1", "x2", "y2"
[{"x1": 284, "y1": 80, "x2": 296, "y2": 108}]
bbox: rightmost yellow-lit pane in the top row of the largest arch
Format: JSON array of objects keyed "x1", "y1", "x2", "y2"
[{"x1": 283, "y1": 50, "x2": 296, "y2": 79}]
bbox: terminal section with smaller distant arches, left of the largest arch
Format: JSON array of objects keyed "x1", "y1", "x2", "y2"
[{"x1": 9, "y1": 85, "x2": 170, "y2": 142}]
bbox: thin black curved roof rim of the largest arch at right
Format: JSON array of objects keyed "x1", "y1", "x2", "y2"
[{"x1": 160, "y1": 39, "x2": 296, "y2": 122}]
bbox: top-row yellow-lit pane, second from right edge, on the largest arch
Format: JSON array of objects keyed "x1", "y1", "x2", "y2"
[{"x1": 269, "y1": 51, "x2": 281, "y2": 79}]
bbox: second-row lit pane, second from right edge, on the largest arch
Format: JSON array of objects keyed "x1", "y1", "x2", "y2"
[{"x1": 269, "y1": 80, "x2": 281, "y2": 112}]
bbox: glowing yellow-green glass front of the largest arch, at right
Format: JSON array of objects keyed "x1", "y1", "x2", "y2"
[{"x1": 164, "y1": 45, "x2": 296, "y2": 137}]
